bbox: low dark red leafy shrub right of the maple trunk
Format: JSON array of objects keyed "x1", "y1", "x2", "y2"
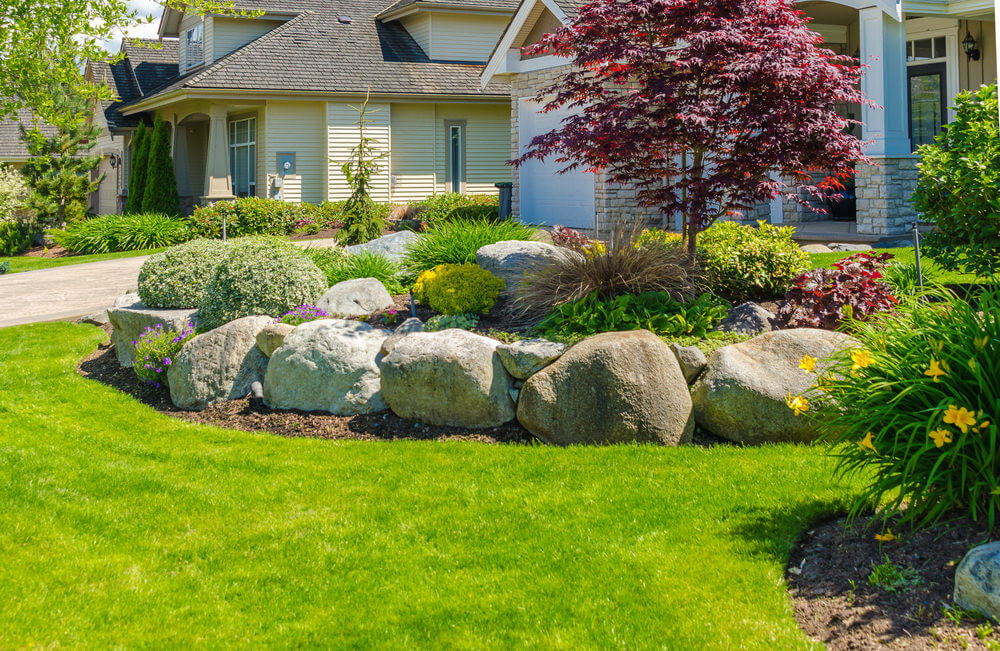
[{"x1": 779, "y1": 252, "x2": 898, "y2": 329}]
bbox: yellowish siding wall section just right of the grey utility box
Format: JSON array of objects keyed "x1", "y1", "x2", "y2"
[{"x1": 266, "y1": 101, "x2": 327, "y2": 203}]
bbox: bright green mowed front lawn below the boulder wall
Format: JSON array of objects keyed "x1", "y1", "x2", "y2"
[{"x1": 0, "y1": 324, "x2": 854, "y2": 649}]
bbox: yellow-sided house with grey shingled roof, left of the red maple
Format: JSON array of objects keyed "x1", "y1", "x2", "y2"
[{"x1": 101, "y1": 0, "x2": 517, "y2": 209}]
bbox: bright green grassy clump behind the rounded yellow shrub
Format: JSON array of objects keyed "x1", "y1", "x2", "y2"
[{"x1": 403, "y1": 219, "x2": 535, "y2": 274}]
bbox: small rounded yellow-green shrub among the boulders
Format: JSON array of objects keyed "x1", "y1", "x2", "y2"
[{"x1": 413, "y1": 264, "x2": 504, "y2": 314}]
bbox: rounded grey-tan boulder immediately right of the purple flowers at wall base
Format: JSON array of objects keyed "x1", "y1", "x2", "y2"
[{"x1": 167, "y1": 316, "x2": 273, "y2": 411}]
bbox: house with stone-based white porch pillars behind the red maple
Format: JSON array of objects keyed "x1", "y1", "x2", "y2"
[{"x1": 482, "y1": 0, "x2": 997, "y2": 239}]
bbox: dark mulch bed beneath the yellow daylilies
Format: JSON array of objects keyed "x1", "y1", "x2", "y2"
[{"x1": 786, "y1": 518, "x2": 1000, "y2": 649}]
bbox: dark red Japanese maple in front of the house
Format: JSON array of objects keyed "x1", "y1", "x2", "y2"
[{"x1": 513, "y1": 0, "x2": 867, "y2": 255}]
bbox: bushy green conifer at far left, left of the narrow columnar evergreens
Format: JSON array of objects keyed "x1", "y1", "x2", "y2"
[{"x1": 20, "y1": 85, "x2": 103, "y2": 227}]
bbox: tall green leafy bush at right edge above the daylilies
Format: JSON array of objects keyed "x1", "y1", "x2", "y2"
[{"x1": 913, "y1": 83, "x2": 1000, "y2": 276}]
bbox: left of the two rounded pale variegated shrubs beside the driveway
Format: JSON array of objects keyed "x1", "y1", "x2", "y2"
[{"x1": 139, "y1": 240, "x2": 227, "y2": 309}]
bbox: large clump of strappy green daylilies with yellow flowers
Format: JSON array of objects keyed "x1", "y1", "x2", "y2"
[{"x1": 789, "y1": 285, "x2": 1000, "y2": 528}]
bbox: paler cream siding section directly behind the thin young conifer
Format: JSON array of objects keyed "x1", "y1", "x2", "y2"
[{"x1": 326, "y1": 102, "x2": 392, "y2": 201}]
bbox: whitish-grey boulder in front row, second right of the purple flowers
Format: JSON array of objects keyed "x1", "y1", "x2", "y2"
[{"x1": 264, "y1": 319, "x2": 389, "y2": 416}]
